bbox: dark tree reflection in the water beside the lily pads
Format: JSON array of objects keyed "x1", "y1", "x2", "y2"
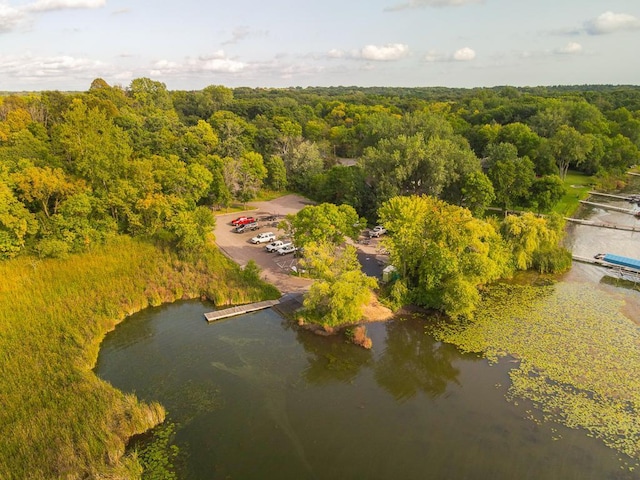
[{"x1": 374, "y1": 319, "x2": 460, "y2": 401}]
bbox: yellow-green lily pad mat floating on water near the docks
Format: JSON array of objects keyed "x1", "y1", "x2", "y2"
[{"x1": 430, "y1": 283, "x2": 640, "y2": 461}]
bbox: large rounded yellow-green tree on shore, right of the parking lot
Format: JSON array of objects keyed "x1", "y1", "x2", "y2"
[{"x1": 378, "y1": 196, "x2": 510, "y2": 317}]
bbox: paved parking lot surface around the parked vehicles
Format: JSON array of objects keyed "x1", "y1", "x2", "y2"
[{"x1": 215, "y1": 195, "x2": 384, "y2": 293}]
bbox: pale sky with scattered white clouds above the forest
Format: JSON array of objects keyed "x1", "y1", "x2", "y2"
[{"x1": 0, "y1": 0, "x2": 640, "y2": 91}]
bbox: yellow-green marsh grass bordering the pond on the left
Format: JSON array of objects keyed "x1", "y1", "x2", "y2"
[{"x1": 0, "y1": 238, "x2": 279, "y2": 480}]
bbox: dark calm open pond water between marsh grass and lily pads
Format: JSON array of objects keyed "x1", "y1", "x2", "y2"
[{"x1": 96, "y1": 302, "x2": 634, "y2": 480}]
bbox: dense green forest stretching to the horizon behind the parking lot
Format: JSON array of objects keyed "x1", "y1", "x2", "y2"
[{"x1": 0, "y1": 78, "x2": 640, "y2": 258}]
